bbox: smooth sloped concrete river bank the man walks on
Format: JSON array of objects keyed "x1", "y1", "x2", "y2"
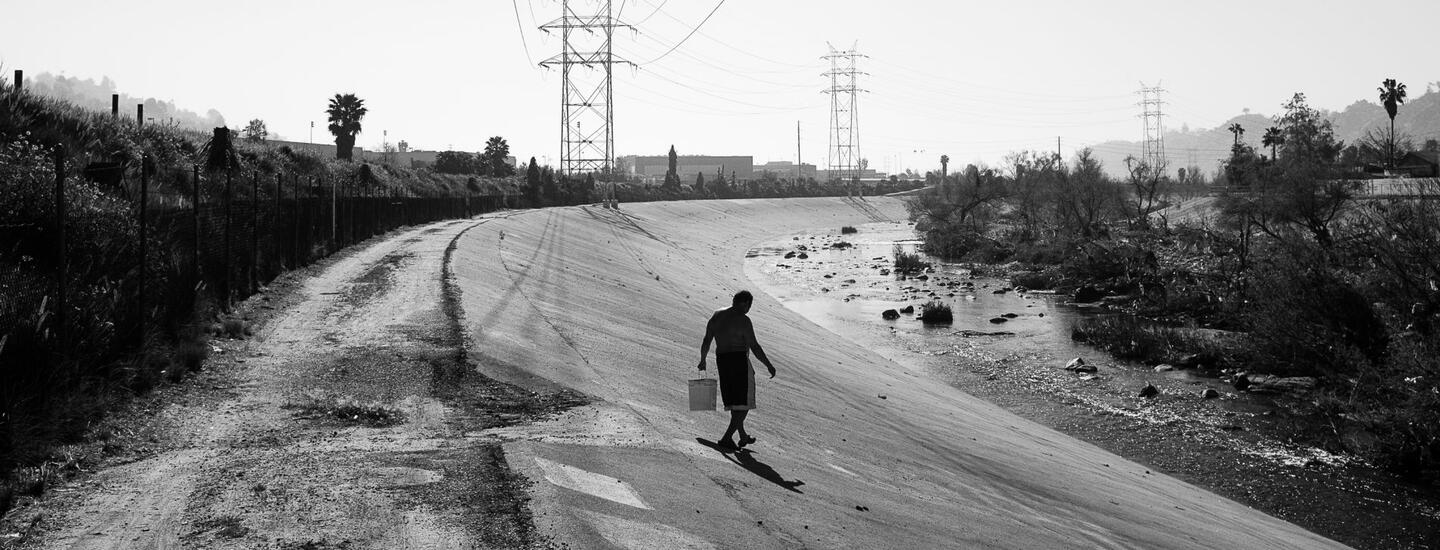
[{"x1": 451, "y1": 199, "x2": 1342, "y2": 549}]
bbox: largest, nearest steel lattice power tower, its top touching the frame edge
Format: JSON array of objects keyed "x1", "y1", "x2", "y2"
[{"x1": 540, "y1": 0, "x2": 635, "y2": 181}]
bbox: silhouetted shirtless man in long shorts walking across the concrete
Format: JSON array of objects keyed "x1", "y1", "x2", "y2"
[{"x1": 700, "y1": 291, "x2": 775, "y2": 449}]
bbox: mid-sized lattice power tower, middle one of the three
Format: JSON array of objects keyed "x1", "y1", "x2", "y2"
[{"x1": 821, "y1": 43, "x2": 864, "y2": 192}]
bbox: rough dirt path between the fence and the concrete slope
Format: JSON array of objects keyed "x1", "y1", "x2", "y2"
[{"x1": 11, "y1": 214, "x2": 577, "y2": 549}]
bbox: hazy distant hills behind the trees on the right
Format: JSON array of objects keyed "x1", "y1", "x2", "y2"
[{"x1": 1092, "y1": 91, "x2": 1440, "y2": 176}]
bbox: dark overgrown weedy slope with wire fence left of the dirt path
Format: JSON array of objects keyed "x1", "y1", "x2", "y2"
[{"x1": 0, "y1": 78, "x2": 518, "y2": 513}]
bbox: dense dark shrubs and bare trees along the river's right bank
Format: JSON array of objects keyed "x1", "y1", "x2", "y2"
[{"x1": 910, "y1": 95, "x2": 1440, "y2": 478}]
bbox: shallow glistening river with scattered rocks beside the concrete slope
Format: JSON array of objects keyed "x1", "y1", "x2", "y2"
[{"x1": 746, "y1": 223, "x2": 1440, "y2": 549}]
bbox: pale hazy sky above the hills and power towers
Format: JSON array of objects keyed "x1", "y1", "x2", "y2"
[{"x1": 0, "y1": 0, "x2": 1440, "y2": 170}]
